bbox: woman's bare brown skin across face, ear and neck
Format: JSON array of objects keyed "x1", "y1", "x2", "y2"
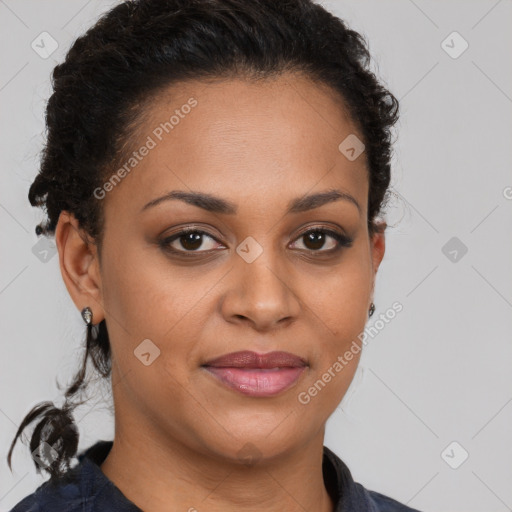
[{"x1": 56, "y1": 74, "x2": 385, "y2": 512}]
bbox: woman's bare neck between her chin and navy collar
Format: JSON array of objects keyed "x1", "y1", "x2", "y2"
[{"x1": 101, "y1": 426, "x2": 334, "y2": 512}]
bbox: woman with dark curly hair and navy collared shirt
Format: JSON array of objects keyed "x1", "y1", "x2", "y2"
[{"x1": 8, "y1": 0, "x2": 413, "y2": 512}]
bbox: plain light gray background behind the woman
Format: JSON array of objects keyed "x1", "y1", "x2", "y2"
[{"x1": 0, "y1": 0, "x2": 512, "y2": 512}]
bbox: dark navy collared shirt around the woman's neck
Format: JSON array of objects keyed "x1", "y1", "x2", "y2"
[{"x1": 11, "y1": 441, "x2": 419, "y2": 512}]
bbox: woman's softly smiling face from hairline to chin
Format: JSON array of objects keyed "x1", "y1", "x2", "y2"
[{"x1": 69, "y1": 75, "x2": 384, "y2": 460}]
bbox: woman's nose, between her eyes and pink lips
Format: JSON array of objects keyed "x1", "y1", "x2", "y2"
[{"x1": 221, "y1": 250, "x2": 300, "y2": 331}]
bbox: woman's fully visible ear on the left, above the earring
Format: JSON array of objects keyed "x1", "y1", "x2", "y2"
[{"x1": 55, "y1": 211, "x2": 105, "y2": 325}]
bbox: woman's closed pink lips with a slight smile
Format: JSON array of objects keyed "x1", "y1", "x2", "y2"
[{"x1": 203, "y1": 350, "x2": 307, "y2": 396}]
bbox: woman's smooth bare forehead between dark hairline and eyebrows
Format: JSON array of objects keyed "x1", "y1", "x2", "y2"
[{"x1": 104, "y1": 74, "x2": 367, "y2": 218}]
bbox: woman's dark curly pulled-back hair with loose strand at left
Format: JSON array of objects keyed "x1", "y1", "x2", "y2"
[{"x1": 7, "y1": 0, "x2": 398, "y2": 479}]
